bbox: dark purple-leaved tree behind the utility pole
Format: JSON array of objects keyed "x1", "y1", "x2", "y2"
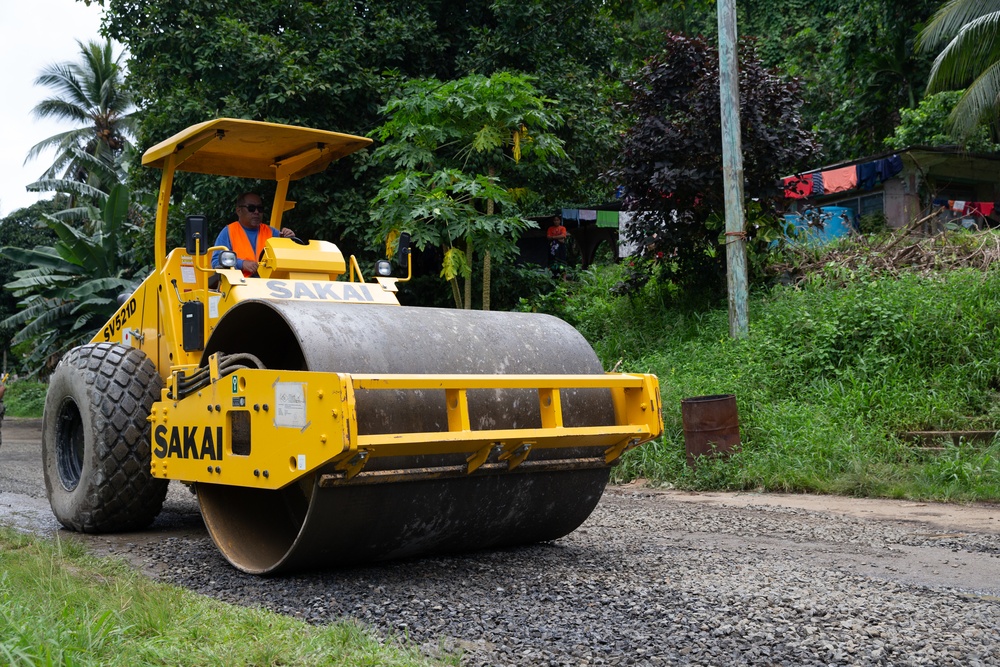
[{"x1": 607, "y1": 33, "x2": 816, "y2": 296}]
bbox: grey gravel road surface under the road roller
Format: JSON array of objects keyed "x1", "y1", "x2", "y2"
[{"x1": 0, "y1": 419, "x2": 1000, "y2": 667}]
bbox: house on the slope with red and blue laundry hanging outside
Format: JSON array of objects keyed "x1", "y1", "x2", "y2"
[{"x1": 783, "y1": 146, "x2": 1000, "y2": 232}]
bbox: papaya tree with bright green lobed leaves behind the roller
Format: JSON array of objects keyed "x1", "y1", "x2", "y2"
[{"x1": 371, "y1": 72, "x2": 566, "y2": 310}]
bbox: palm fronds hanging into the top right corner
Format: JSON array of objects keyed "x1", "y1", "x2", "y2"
[{"x1": 918, "y1": 0, "x2": 1000, "y2": 137}]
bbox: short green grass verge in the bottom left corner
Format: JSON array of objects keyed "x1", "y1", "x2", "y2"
[{"x1": 0, "y1": 527, "x2": 458, "y2": 667}]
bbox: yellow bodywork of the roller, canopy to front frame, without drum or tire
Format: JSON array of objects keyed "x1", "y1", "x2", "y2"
[{"x1": 92, "y1": 119, "x2": 663, "y2": 489}]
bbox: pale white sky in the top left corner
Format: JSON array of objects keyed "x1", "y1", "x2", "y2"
[{"x1": 0, "y1": 0, "x2": 106, "y2": 218}]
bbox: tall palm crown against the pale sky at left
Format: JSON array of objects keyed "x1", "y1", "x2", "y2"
[{"x1": 25, "y1": 40, "x2": 133, "y2": 192}]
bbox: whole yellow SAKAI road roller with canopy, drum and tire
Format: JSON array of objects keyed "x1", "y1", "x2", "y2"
[{"x1": 42, "y1": 118, "x2": 663, "y2": 574}]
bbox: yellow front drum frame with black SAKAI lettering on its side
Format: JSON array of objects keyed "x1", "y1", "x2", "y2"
[{"x1": 150, "y1": 369, "x2": 663, "y2": 489}]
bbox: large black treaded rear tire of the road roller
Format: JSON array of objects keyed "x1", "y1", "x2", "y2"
[{"x1": 42, "y1": 343, "x2": 168, "y2": 533}]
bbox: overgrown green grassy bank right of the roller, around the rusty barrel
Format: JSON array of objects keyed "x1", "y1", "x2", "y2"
[{"x1": 539, "y1": 267, "x2": 1000, "y2": 501}]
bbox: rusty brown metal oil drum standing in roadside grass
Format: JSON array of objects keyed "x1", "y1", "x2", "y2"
[{"x1": 681, "y1": 394, "x2": 740, "y2": 465}]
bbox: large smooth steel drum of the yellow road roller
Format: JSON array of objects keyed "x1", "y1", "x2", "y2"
[{"x1": 197, "y1": 300, "x2": 615, "y2": 574}]
